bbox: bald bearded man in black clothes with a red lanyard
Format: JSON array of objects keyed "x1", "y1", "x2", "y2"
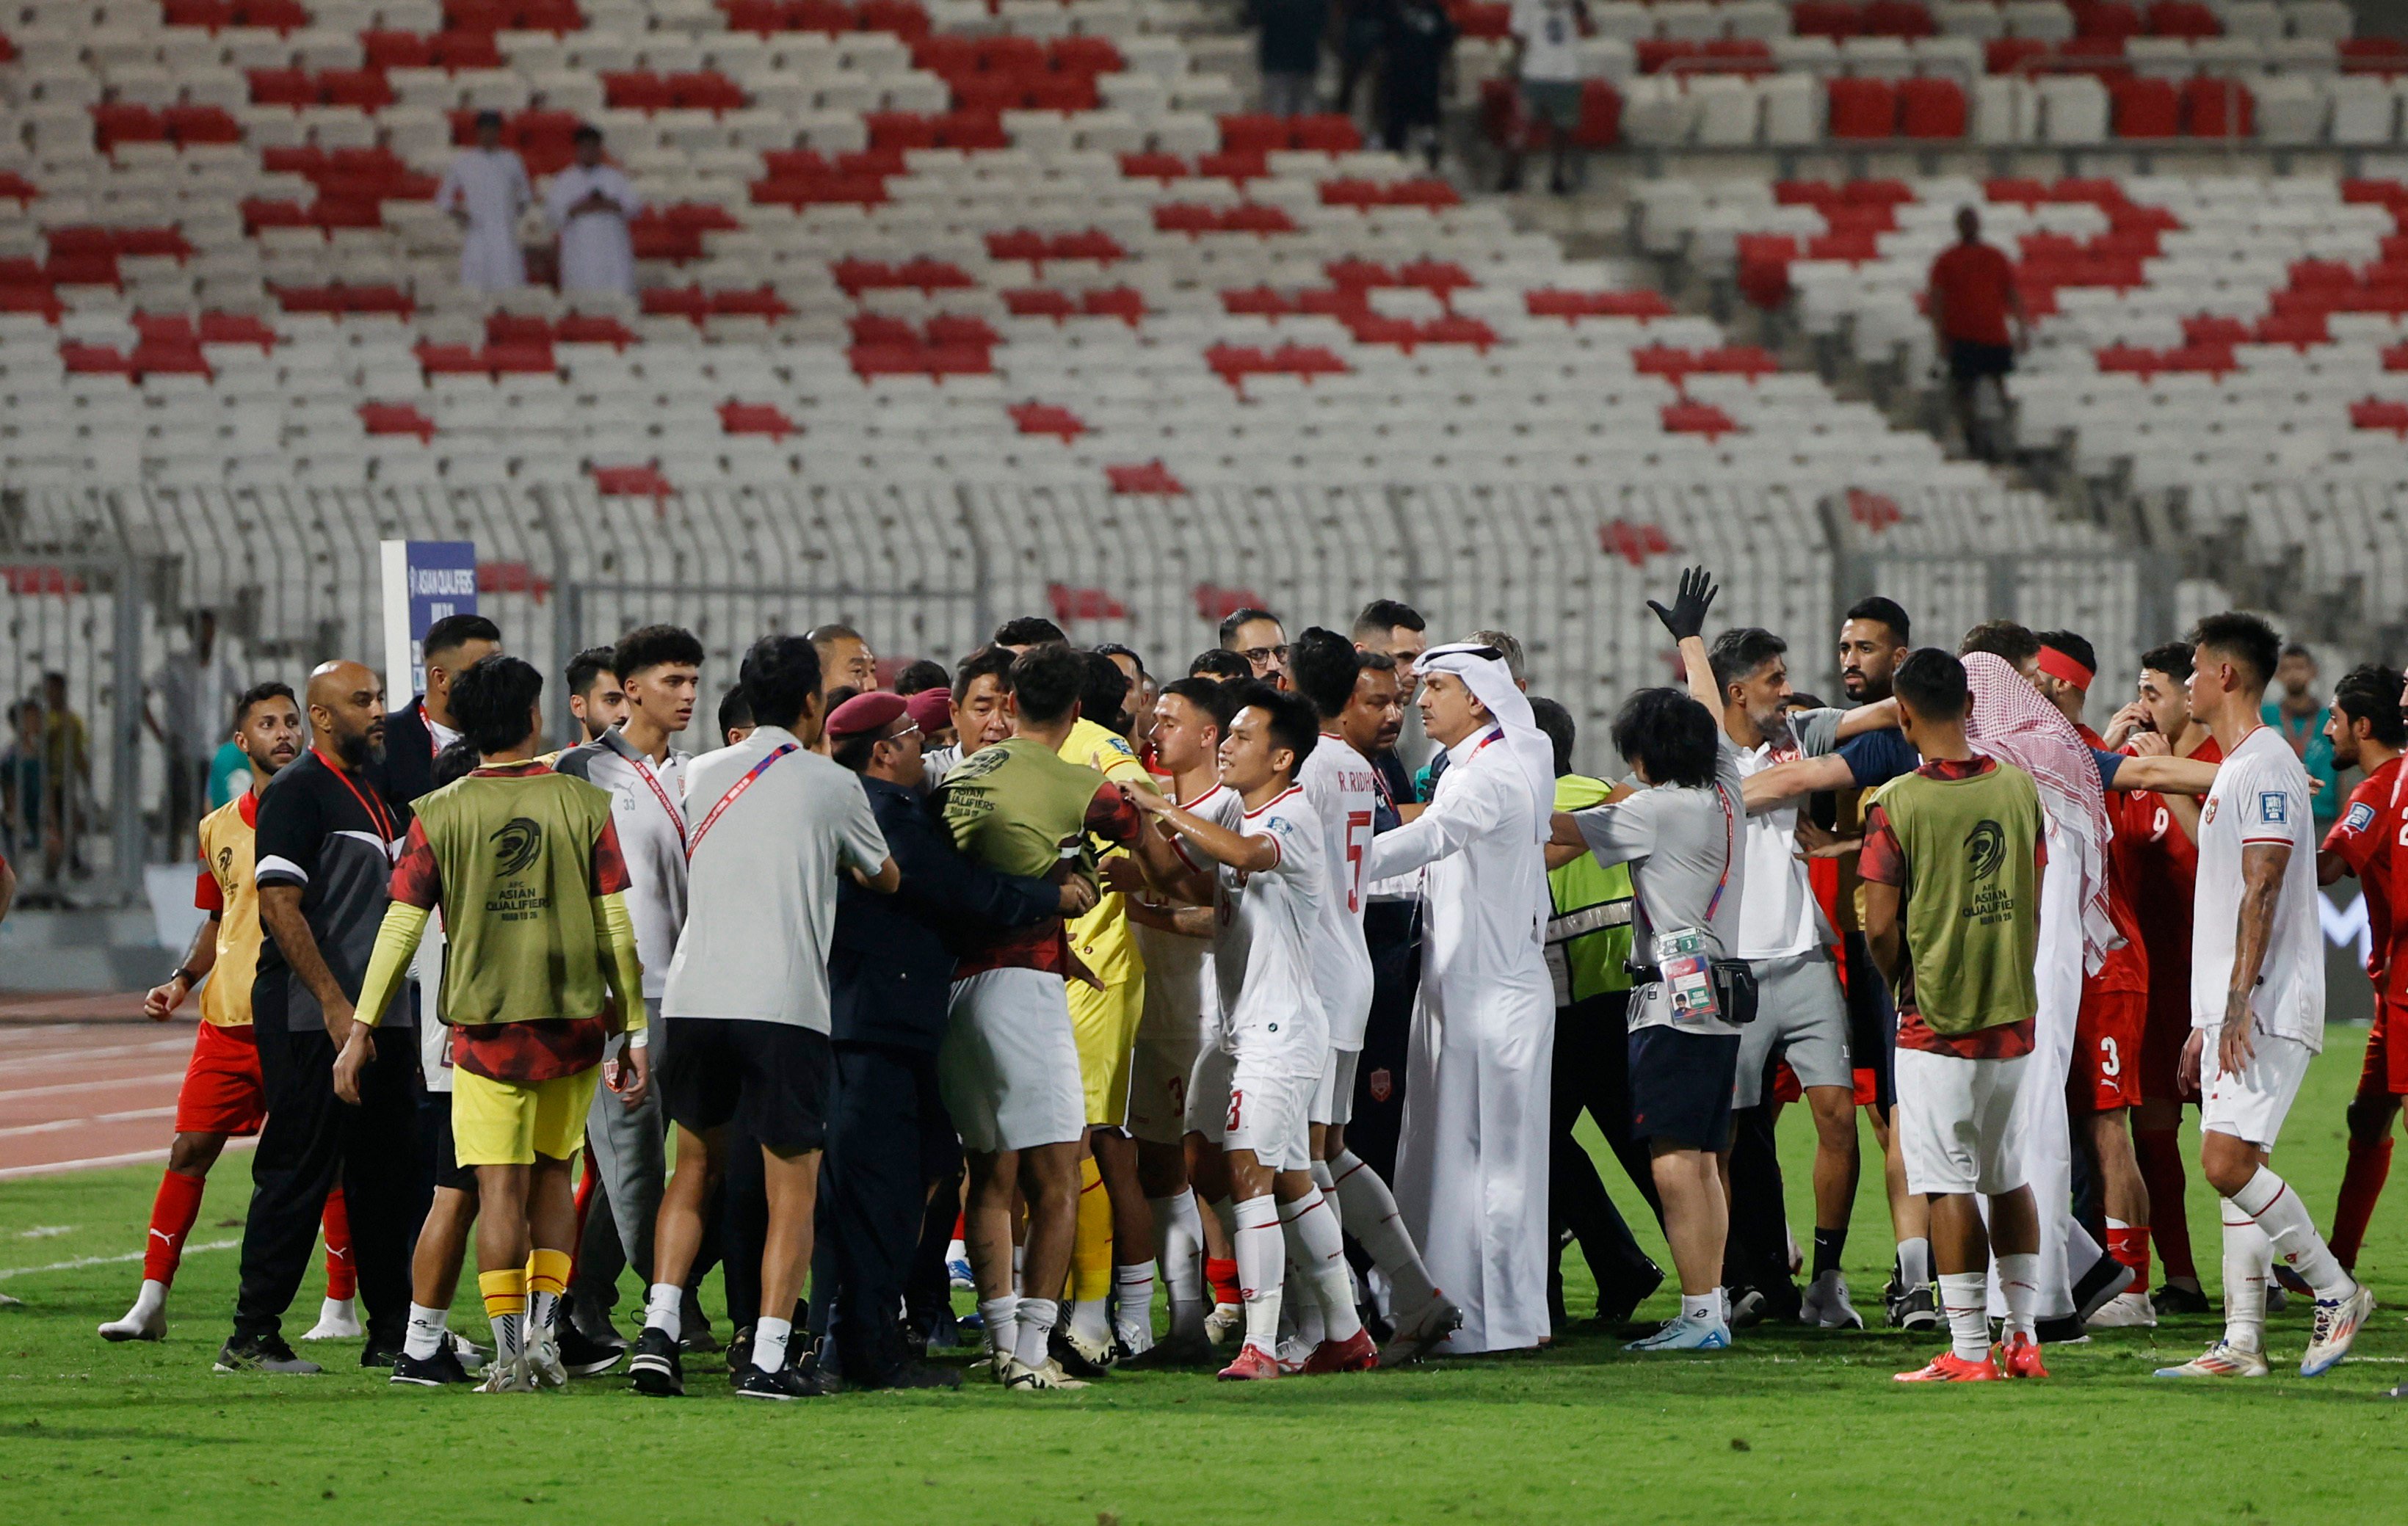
[{"x1": 217, "y1": 662, "x2": 419, "y2": 1374}]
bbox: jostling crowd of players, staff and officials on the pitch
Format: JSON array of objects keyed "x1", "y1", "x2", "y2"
[{"x1": 70, "y1": 570, "x2": 2408, "y2": 1398}]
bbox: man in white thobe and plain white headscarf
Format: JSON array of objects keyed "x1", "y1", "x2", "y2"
[{"x1": 1370, "y1": 645, "x2": 1556, "y2": 1355}]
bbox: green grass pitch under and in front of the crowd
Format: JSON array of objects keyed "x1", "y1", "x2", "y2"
[{"x1": 0, "y1": 1030, "x2": 2408, "y2": 1526}]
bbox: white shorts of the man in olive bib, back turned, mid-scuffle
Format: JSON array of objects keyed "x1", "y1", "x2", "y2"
[{"x1": 937, "y1": 970, "x2": 1086, "y2": 1155}]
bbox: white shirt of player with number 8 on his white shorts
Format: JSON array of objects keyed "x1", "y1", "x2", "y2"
[{"x1": 1211, "y1": 785, "x2": 1330, "y2": 1076}]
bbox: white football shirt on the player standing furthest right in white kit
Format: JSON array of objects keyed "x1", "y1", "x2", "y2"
[{"x1": 2191, "y1": 727, "x2": 2324, "y2": 1052}]
